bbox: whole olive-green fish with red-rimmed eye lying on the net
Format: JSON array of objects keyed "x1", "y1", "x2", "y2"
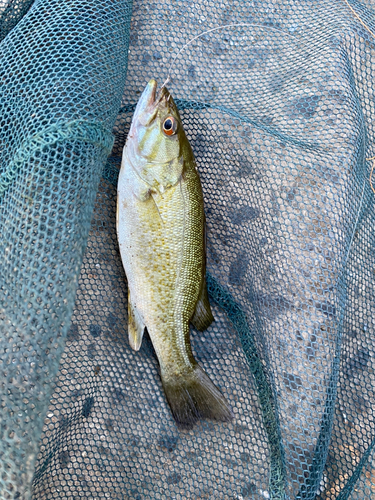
[{"x1": 116, "y1": 79, "x2": 233, "y2": 427}]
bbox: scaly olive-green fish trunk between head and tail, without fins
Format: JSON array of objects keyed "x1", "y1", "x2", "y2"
[{"x1": 119, "y1": 154, "x2": 204, "y2": 373}]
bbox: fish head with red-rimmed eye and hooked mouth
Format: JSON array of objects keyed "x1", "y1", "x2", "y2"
[{"x1": 125, "y1": 79, "x2": 188, "y2": 193}]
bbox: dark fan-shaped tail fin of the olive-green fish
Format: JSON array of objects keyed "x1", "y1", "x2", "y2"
[{"x1": 162, "y1": 365, "x2": 233, "y2": 428}]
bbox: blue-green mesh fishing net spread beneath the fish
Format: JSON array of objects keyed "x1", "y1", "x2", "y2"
[{"x1": 0, "y1": 0, "x2": 375, "y2": 500}]
